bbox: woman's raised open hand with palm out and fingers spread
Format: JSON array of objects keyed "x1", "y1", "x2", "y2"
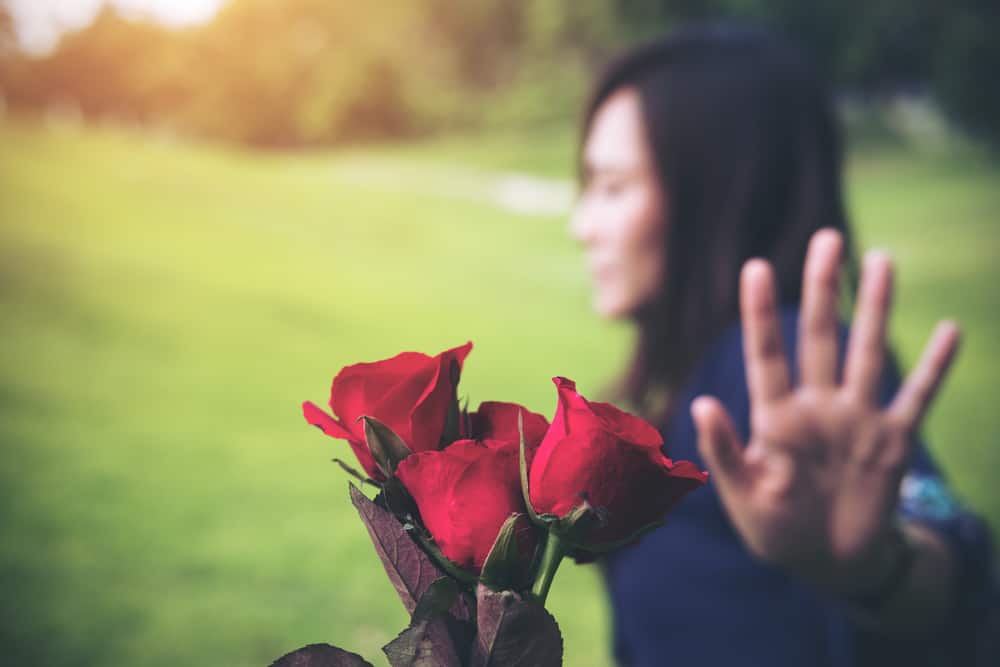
[{"x1": 692, "y1": 229, "x2": 958, "y2": 595}]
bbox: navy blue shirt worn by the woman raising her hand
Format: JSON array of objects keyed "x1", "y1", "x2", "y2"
[{"x1": 604, "y1": 309, "x2": 991, "y2": 667}]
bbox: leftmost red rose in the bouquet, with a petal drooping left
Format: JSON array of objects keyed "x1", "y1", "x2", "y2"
[{"x1": 302, "y1": 343, "x2": 472, "y2": 480}]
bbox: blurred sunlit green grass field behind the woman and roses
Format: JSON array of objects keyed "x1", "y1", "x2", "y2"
[{"x1": 0, "y1": 123, "x2": 1000, "y2": 667}]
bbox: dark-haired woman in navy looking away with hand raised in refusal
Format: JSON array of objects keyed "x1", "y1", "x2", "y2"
[{"x1": 572, "y1": 26, "x2": 990, "y2": 666}]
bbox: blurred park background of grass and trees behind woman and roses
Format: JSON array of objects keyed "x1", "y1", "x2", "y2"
[{"x1": 0, "y1": 0, "x2": 1000, "y2": 667}]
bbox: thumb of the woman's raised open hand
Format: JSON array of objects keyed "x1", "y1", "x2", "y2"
[{"x1": 691, "y1": 396, "x2": 749, "y2": 494}]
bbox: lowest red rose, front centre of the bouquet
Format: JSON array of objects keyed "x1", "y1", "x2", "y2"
[{"x1": 396, "y1": 440, "x2": 534, "y2": 574}]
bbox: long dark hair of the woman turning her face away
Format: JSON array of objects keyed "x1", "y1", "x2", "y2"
[{"x1": 580, "y1": 24, "x2": 856, "y2": 417}]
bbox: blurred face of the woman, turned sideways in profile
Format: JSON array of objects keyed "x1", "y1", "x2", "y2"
[{"x1": 570, "y1": 87, "x2": 666, "y2": 318}]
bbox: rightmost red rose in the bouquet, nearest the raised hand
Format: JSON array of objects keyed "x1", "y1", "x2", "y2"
[{"x1": 529, "y1": 378, "x2": 708, "y2": 546}]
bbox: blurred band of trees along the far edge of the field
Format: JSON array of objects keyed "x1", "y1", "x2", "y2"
[{"x1": 0, "y1": 0, "x2": 1000, "y2": 146}]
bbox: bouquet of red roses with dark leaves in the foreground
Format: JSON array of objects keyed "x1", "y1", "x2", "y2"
[{"x1": 274, "y1": 343, "x2": 707, "y2": 667}]
